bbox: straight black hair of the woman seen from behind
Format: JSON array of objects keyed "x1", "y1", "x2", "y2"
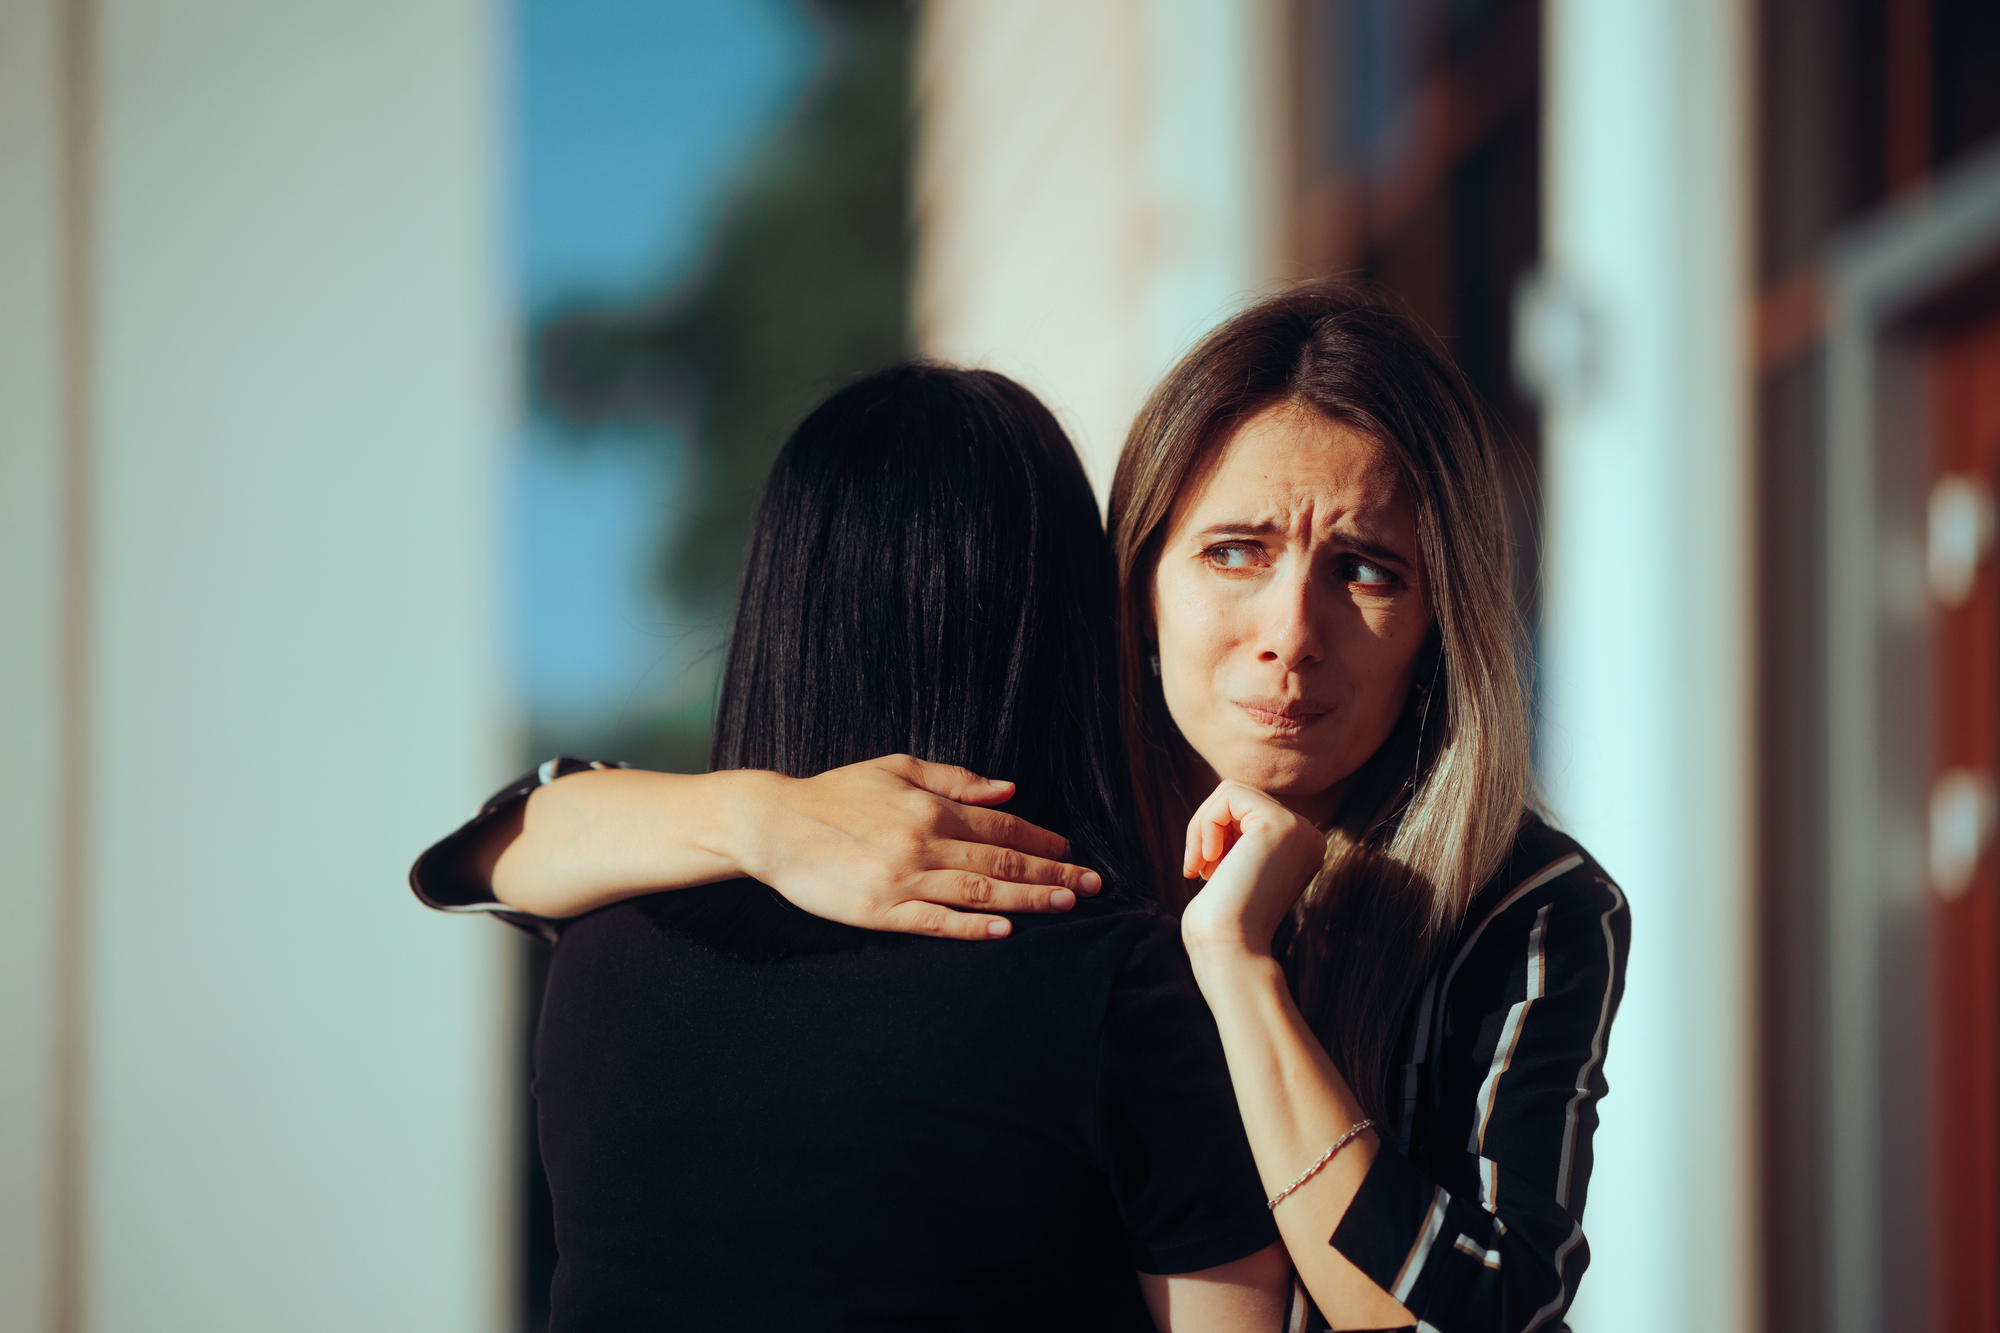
[{"x1": 648, "y1": 362, "x2": 1152, "y2": 953}]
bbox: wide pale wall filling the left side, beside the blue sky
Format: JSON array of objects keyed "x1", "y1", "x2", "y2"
[{"x1": 0, "y1": 0, "x2": 516, "y2": 1333}]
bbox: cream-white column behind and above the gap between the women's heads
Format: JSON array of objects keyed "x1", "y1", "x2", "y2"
[{"x1": 916, "y1": 0, "x2": 1288, "y2": 494}]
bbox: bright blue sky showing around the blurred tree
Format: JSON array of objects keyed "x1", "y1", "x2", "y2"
[{"x1": 506, "y1": 0, "x2": 818, "y2": 745}]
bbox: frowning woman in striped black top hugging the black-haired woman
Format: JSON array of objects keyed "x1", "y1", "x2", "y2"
[{"x1": 418, "y1": 282, "x2": 1630, "y2": 1331}]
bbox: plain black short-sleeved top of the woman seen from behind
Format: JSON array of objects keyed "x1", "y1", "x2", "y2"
[{"x1": 534, "y1": 881, "x2": 1278, "y2": 1333}]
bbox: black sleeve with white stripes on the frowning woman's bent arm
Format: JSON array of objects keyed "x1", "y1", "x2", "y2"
[{"x1": 1332, "y1": 835, "x2": 1630, "y2": 1333}]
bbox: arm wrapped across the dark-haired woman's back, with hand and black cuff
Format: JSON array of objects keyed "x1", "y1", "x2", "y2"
[{"x1": 420, "y1": 755, "x2": 1100, "y2": 939}]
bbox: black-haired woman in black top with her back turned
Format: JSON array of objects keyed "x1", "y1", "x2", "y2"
[{"x1": 432, "y1": 364, "x2": 1288, "y2": 1333}]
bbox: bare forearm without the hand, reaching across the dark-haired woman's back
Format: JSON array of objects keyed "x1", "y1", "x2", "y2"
[{"x1": 490, "y1": 769, "x2": 760, "y2": 917}]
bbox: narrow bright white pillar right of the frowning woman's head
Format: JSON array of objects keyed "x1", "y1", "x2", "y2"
[{"x1": 1542, "y1": 0, "x2": 1758, "y2": 1333}]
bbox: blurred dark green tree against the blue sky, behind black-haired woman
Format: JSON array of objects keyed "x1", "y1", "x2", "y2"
[{"x1": 530, "y1": 0, "x2": 916, "y2": 771}]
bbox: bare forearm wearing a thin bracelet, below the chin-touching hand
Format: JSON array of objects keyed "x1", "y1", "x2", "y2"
[{"x1": 1194, "y1": 949, "x2": 1410, "y2": 1327}]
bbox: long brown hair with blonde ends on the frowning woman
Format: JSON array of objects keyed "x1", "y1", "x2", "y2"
[{"x1": 1110, "y1": 280, "x2": 1532, "y2": 1119}]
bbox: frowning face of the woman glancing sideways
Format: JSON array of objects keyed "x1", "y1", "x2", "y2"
[{"x1": 1152, "y1": 404, "x2": 1430, "y2": 821}]
